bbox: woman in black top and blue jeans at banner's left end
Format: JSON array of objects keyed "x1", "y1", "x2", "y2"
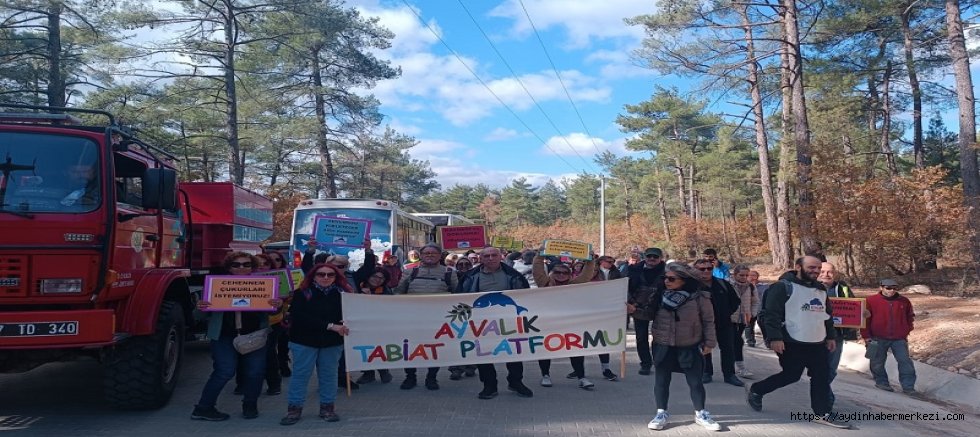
[{"x1": 279, "y1": 264, "x2": 351, "y2": 425}]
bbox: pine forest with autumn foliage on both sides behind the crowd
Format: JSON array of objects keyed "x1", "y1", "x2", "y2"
[{"x1": 0, "y1": 0, "x2": 980, "y2": 281}]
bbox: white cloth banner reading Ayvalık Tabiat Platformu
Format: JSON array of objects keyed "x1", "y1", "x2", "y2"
[{"x1": 343, "y1": 279, "x2": 628, "y2": 371}]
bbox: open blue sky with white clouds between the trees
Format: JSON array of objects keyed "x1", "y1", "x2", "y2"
[{"x1": 348, "y1": 0, "x2": 674, "y2": 188}]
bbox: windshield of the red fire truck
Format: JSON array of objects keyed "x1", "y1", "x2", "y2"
[{"x1": 0, "y1": 132, "x2": 101, "y2": 213}]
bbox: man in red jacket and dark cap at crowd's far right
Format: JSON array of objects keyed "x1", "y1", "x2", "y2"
[{"x1": 861, "y1": 279, "x2": 915, "y2": 395}]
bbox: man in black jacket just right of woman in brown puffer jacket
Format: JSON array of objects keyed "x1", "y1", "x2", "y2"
[{"x1": 694, "y1": 255, "x2": 745, "y2": 387}]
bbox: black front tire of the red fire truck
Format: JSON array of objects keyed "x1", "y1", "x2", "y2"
[{"x1": 103, "y1": 301, "x2": 185, "y2": 410}]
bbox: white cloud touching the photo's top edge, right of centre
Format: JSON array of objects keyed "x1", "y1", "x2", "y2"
[{"x1": 490, "y1": 0, "x2": 655, "y2": 47}]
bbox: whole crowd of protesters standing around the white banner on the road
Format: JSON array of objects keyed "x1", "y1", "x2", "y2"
[{"x1": 191, "y1": 241, "x2": 915, "y2": 431}]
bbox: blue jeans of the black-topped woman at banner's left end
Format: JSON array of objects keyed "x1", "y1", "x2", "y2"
[{"x1": 286, "y1": 342, "x2": 344, "y2": 407}]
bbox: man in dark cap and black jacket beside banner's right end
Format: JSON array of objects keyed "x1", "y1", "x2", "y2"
[{"x1": 626, "y1": 247, "x2": 665, "y2": 375}]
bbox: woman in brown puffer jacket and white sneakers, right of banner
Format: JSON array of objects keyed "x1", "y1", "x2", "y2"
[{"x1": 645, "y1": 263, "x2": 724, "y2": 431}]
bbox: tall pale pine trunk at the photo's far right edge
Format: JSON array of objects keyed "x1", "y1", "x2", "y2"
[{"x1": 946, "y1": 0, "x2": 980, "y2": 277}]
